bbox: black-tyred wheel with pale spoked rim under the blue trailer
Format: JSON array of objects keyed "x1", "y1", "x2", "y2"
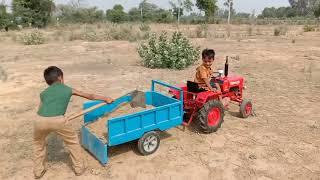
[{"x1": 138, "y1": 131, "x2": 160, "y2": 156}]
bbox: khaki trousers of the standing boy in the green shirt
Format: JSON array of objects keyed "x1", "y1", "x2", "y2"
[{"x1": 33, "y1": 116, "x2": 84, "y2": 176}]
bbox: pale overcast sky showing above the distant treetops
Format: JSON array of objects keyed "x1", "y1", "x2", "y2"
[{"x1": 6, "y1": 0, "x2": 289, "y2": 14}]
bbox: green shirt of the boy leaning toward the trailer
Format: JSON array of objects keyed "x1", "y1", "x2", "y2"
[{"x1": 38, "y1": 83, "x2": 72, "y2": 117}]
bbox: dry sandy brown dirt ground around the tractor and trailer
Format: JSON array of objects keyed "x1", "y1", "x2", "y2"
[{"x1": 0, "y1": 24, "x2": 320, "y2": 180}]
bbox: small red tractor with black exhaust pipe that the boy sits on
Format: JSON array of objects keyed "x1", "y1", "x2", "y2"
[{"x1": 169, "y1": 57, "x2": 253, "y2": 133}]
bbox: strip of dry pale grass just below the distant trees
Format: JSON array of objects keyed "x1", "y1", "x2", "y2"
[{"x1": 0, "y1": 23, "x2": 310, "y2": 42}]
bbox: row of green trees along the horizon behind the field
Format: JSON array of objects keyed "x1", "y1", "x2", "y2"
[{"x1": 0, "y1": 0, "x2": 320, "y2": 29}]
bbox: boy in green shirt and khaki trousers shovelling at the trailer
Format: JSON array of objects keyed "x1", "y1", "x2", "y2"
[{"x1": 33, "y1": 66, "x2": 113, "y2": 179}]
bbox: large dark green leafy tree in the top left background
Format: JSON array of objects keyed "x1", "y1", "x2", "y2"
[{"x1": 12, "y1": 0, "x2": 55, "y2": 27}]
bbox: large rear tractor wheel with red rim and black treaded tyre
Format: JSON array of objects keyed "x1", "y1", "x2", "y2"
[{"x1": 197, "y1": 100, "x2": 224, "y2": 133}]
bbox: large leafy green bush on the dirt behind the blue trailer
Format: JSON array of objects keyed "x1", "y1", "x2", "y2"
[{"x1": 138, "y1": 32, "x2": 200, "y2": 69}]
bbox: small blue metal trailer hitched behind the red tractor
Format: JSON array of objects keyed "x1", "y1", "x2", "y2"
[{"x1": 81, "y1": 80, "x2": 184, "y2": 165}]
